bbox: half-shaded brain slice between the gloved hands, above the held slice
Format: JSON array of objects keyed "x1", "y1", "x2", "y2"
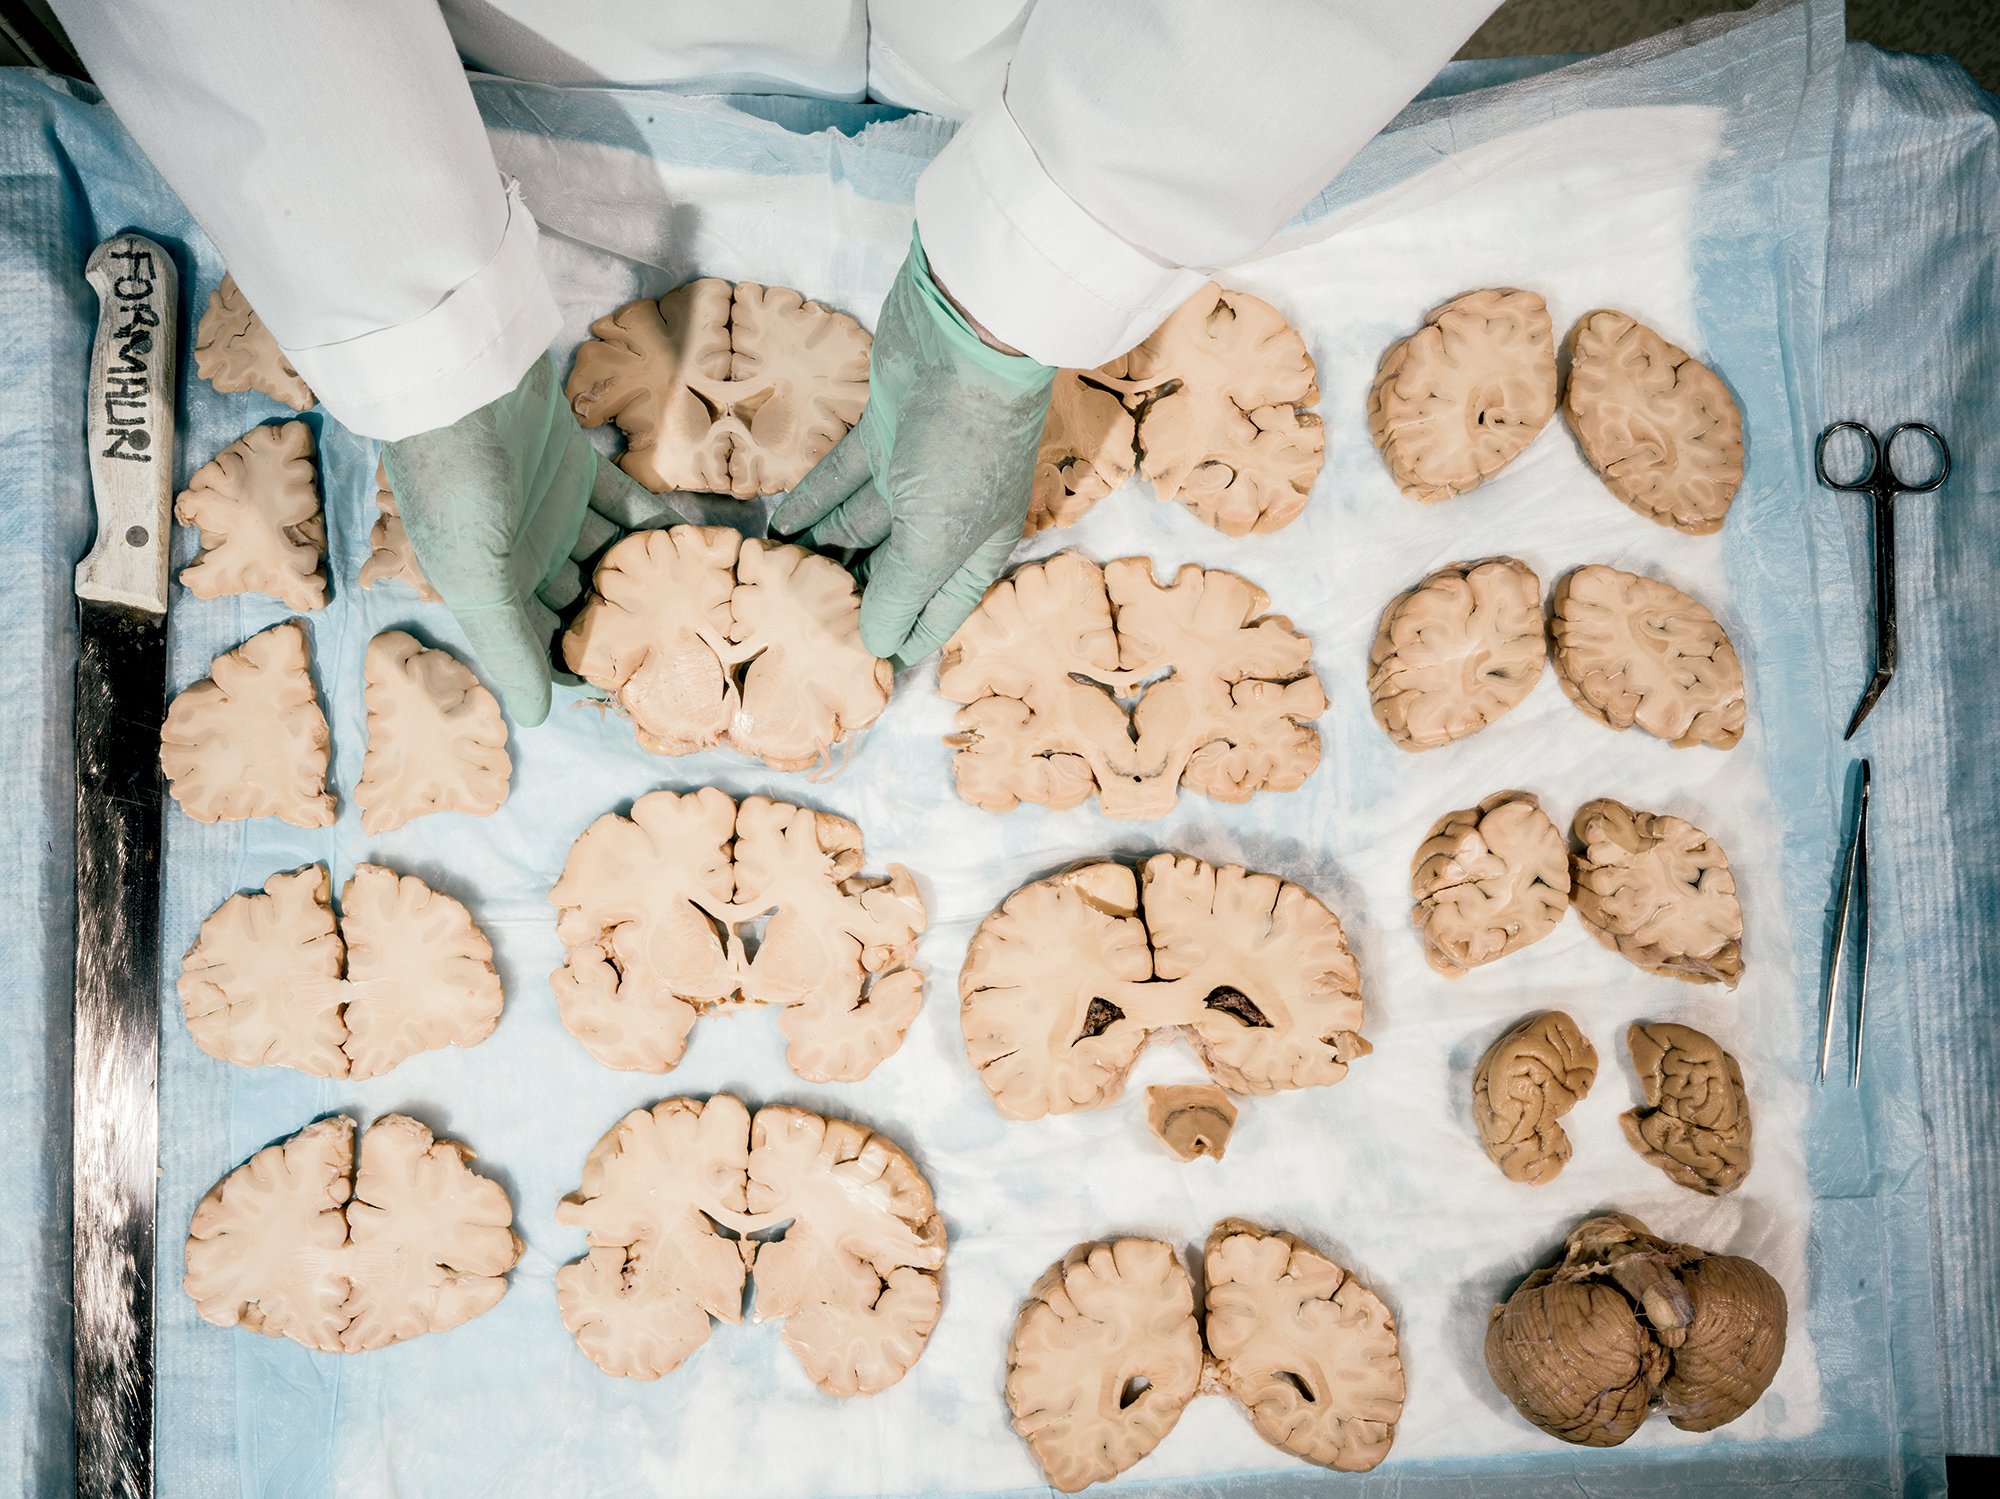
[{"x1": 568, "y1": 276, "x2": 872, "y2": 500}]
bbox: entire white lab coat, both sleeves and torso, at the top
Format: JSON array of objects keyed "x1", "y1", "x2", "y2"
[{"x1": 56, "y1": 0, "x2": 1494, "y2": 440}]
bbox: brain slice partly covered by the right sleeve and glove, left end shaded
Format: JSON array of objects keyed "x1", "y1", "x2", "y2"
[{"x1": 1028, "y1": 284, "x2": 1326, "y2": 536}]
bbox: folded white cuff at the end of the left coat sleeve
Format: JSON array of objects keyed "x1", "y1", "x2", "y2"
[{"x1": 286, "y1": 182, "x2": 562, "y2": 442}]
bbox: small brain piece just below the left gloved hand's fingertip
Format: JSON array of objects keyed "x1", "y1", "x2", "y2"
[{"x1": 354, "y1": 630, "x2": 514, "y2": 833}]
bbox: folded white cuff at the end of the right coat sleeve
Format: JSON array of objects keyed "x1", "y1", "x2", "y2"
[{"x1": 916, "y1": 98, "x2": 1208, "y2": 370}]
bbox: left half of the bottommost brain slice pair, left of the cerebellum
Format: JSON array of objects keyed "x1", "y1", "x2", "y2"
[{"x1": 1006, "y1": 1239, "x2": 1202, "y2": 1493}]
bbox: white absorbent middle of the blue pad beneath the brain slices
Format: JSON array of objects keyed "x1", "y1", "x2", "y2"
[{"x1": 162, "y1": 96, "x2": 1820, "y2": 1495}]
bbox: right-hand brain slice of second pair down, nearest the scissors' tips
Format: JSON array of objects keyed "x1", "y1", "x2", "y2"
[{"x1": 1548, "y1": 566, "x2": 1744, "y2": 750}]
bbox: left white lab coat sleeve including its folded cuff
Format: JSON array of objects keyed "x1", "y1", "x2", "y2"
[{"x1": 54, "y1": 0, "x2": 560, "y2": 440}]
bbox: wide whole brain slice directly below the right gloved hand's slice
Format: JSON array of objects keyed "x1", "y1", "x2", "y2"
[{"x1": 938, "y1": 552, "x2": 1326, "y2": 817}]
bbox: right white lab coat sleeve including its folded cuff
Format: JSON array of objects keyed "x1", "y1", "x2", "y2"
[{"x1": 916, "y1": 0, "x2": 1496, "y2": 368}]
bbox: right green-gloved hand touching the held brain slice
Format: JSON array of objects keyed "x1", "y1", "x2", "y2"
[{"x1": 770, "y1": 232, "x2": 1056, "y2": 666}]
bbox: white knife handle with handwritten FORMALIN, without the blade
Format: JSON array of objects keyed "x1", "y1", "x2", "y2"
[{"x1": 76, "y1": 234, "x2": 180, "y2": 614}]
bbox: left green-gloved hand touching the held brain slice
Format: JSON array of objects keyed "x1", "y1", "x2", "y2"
[{"x1": 382, "y1": 358, "x2": 680, "y2": 728}]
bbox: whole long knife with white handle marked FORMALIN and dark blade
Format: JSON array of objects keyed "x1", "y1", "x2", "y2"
[{"x1": 70, "y1": 234, "x2": 180, "y2": 1499}]
